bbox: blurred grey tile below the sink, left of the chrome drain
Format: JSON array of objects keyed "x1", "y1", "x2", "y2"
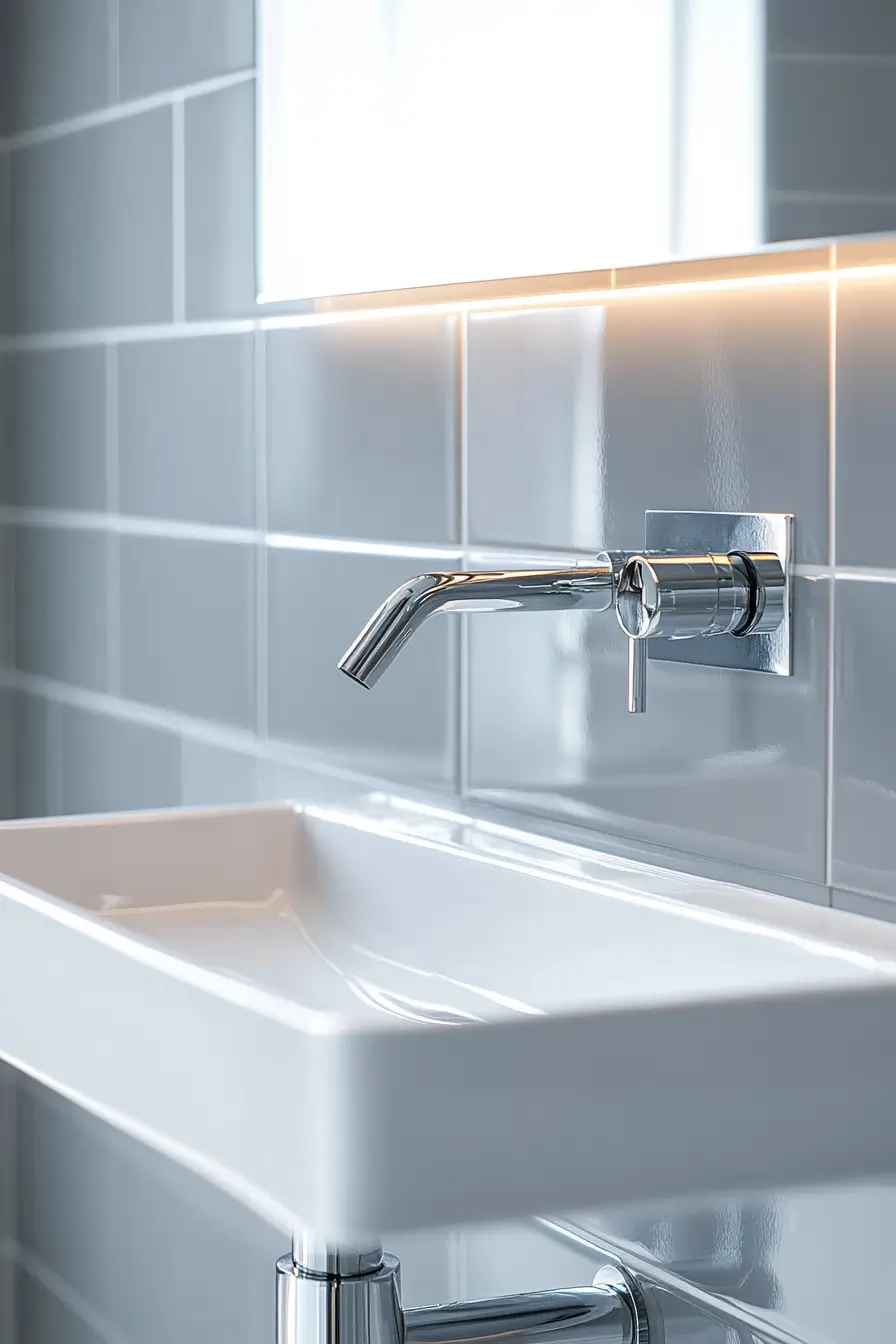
[{"x1": 19, "y1": 1083, "x2": 287, "y2": 1344}]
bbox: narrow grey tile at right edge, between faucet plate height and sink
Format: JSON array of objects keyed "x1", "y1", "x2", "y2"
[{"x1": 832, "y1": 581, "x2": 896, "y2": 896}]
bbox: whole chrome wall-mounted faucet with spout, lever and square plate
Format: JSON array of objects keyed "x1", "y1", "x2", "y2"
[{"x1": 339, "y1": 511, "x2": 793, "y2": 714}]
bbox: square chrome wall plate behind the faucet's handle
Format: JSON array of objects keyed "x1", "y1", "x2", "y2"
[{"x1": 645, "y1": 509, "x2": 794, "y2": 676}]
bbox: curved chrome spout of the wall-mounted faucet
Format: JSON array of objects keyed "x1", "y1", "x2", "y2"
[{"x1": 339, "y1": 552, "x2": 625, "y2": 689}]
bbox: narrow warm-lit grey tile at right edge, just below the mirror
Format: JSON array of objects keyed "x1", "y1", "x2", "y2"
[{"x1": 837, "y1": 276, "x2": 896, "y2": 569}]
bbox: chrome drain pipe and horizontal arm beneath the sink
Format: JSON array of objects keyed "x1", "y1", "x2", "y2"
[{"x1": 277, "y1": 1243, "x2": 652, "y2": 1344}]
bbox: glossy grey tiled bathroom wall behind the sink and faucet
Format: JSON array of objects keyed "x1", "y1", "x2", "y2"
[{"x1": 0, "y1": 0, "x2": 896, "y2": 1344}]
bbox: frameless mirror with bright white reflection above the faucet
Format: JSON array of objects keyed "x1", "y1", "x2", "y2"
[{"x1": 258, "y1": 0, "x2": 896, "y2": 302}]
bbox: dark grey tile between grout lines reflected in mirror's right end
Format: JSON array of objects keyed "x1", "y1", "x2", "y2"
[{"x1": 766, "y1": 60, "x2": 896, "y2": 195}]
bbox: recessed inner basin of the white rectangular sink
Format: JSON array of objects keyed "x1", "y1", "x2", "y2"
[{"x1": 0, "y1": 805, "x2": 892, "y2": 1030}]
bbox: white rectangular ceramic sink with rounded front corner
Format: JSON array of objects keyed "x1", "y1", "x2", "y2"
[{"x1": 0, "y1": 800, "x2": 896, "y2": 1238}]
